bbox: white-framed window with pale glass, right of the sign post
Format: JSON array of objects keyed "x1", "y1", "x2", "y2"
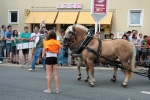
[{"x1": 128, "y1": 10, "x2": 144, "y2": 27}]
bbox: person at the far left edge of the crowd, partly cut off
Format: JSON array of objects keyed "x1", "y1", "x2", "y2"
[{"x1": 0, "y1": 25, "x2": 6, "y2": 64}]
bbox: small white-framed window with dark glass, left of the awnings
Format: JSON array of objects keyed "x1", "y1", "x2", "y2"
[{"x1": 8, "y1": 10, "x2": 19, "y2": 24}]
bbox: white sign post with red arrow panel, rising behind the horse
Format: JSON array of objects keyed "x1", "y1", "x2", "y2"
[{"x1": 91, "y1": 0, "x2": 109, "y2": 34}]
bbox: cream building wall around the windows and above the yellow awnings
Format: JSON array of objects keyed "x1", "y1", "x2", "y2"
[{"x1": 0, "y1": 0, "x2": 150, "y2": 35}]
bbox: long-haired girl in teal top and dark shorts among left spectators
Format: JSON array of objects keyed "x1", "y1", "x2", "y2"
[{"x1": 11, "y1": 30, "x2": 19, "y2": 64}]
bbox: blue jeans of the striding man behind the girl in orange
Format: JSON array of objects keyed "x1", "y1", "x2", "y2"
[{"x1": 31, "y1": 48, "x2": 46, "y2": 70}]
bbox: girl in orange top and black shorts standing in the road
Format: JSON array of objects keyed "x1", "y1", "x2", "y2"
[{"x1": 42, "y1": 31, "x2": 61, "y2": 93}]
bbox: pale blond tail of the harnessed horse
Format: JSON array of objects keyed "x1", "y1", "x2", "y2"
[{"x1": 129, "y1": 42, "x2": 136, "y2": 79}]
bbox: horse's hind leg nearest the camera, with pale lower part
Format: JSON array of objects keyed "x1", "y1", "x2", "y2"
[{"x1": 122, "y1": 62, "x2": 130, "y2": 87}]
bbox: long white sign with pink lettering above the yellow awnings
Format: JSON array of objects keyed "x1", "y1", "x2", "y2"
[{"x1": 56, "y1": 3, "x2": 82, "y2": 8}]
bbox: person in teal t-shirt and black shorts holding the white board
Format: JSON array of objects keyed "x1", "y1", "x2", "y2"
[{"x1": 20, "y1": 26, "x2": 31, "y2": 66}]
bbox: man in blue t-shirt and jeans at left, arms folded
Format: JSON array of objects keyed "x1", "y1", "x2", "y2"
[{"x1": 5, "y1": 25, "x2": 13, "y2": 62}]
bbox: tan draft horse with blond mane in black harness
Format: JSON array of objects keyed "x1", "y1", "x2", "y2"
[{"x1": 63, "y1": 24, "x2": 135, "y2": 87}]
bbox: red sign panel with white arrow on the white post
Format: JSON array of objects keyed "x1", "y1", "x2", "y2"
[{"x1": 94, "y1": 0, "x2": 107, "y2": 14}]
